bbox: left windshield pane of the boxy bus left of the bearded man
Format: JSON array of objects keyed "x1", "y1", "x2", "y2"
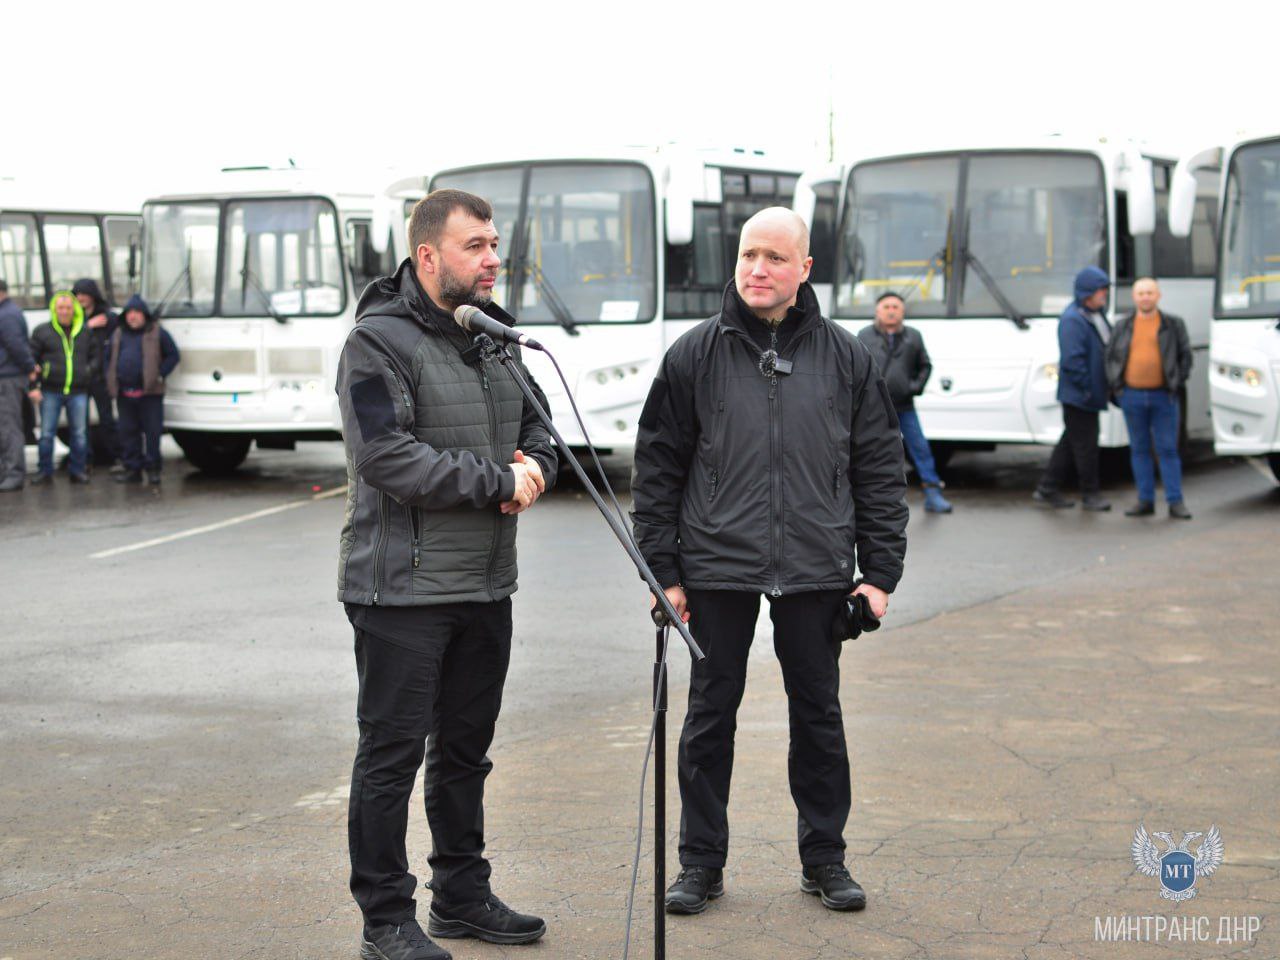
[{"x1": 142, "y1": 202, "x2": 218, "y2": 316}]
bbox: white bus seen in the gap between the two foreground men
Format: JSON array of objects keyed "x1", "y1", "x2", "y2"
[{"x1": 431, "y1": 147, "x2": 799, "y2": 454}]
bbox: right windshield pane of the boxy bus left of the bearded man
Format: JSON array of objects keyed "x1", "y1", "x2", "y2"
[{"x1": 220, "y1": 197, "x2": 346, "y2": 316}]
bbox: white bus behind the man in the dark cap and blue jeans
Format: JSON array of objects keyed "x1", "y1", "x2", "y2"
[{"x1": 796, "y1": 137, "x2": 1216, "y2": 461}]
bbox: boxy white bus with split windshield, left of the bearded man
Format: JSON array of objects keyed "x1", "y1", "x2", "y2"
[{"x1": 142, "y1": 168, "x2": 424, "y2": 474}]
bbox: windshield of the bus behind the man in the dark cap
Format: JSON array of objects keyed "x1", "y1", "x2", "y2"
[{"x1": 836, "y1": 152, "x2": 1107, "y2": 317}]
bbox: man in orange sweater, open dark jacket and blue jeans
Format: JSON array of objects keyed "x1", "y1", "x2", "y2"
[{"x1": 1107, "y1": 276, "x2": 1192, "y2": 520}]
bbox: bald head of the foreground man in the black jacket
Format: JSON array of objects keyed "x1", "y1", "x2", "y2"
[{"x1": 733, "y1": 206, "x2": 813, "y2": 324}]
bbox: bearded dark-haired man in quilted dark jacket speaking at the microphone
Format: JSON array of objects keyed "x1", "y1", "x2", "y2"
[{"x1": 338, "y1": 191, "x2": 556, "y2": 960}]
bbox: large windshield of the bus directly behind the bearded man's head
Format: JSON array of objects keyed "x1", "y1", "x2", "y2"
[{"x1": 431, "y1": 163, "x2": 657, "y2": 326}]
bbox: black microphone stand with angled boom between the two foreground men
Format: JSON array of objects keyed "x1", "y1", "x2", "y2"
[{"x1": 472, "y1": 333, "x2": 707, "y2": 960}]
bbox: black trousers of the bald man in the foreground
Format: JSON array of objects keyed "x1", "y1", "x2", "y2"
[{"x1": 678, "y1": 590, "x2": 851, "y2": 868}]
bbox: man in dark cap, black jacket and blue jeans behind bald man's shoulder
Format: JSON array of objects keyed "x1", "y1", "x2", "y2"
[{"x1": 858, "y1": 292, "x2": 951, "y2": 513}]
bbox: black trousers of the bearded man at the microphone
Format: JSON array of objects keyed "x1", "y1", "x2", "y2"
[{"x1": 347, "y1": 599, "x2": 511, "y2": 925}]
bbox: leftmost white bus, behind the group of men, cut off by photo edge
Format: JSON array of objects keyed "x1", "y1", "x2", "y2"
[{"x1": 0, "y1": 185, "x2": 142, "y2": 457}]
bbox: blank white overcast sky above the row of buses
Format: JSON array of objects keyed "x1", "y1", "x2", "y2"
[{"x1": 0, "y1": 0, "x2": 1280, "y2": 192}]
